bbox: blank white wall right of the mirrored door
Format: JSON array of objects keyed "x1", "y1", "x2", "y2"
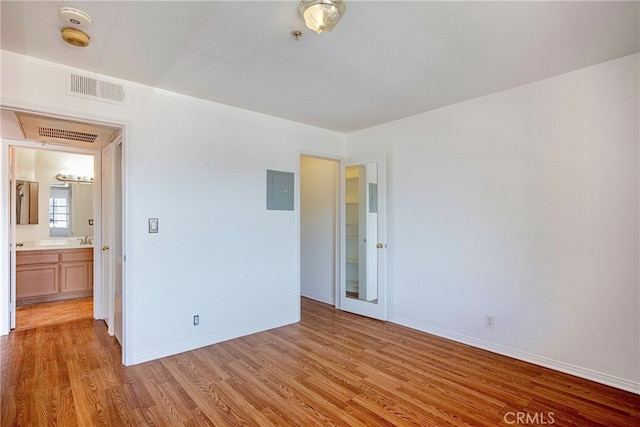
[{"x1": 347, "y1": 54, "x2": 640, "y2": 392}]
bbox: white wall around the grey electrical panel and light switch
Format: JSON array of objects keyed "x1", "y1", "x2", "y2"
[{"x1": 0, "y1": 51, "x2": 345, "y2": 363}]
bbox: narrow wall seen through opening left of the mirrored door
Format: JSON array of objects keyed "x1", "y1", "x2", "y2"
[{"x1": 300, "y1": 157, "x2": 339, "y2": 305}]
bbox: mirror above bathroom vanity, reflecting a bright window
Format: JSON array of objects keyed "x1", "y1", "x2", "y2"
[{"x1": 49, "y1": 181, "x2": 93, "y2": 237}]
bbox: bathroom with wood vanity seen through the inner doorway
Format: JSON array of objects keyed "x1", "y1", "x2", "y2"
[{"x1": 11, "y1": 147, "x2": 100, "y2": 330}]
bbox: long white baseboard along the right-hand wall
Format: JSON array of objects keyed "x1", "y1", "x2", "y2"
[{"x1": 388, "y1": 316, "x2": 640, "y2": 394}]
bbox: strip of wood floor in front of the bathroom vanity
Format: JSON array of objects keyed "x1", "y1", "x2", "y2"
[{"x1": 15, "y1": 297, "x2": 93, "y2": 331}]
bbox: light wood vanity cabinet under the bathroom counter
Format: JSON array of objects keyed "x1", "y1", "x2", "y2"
[{"x1": 16, "y1": 248, "x2": 93, "y2": 305}]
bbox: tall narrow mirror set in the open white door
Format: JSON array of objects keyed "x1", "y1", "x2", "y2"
[{"x1": 345, "y1": 162, "x2": 379, "y2": 304}]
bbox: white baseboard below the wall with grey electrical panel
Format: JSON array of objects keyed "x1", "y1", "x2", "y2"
[{"x1": 132, "y1": 316, "x2": 300, "y2": 365}]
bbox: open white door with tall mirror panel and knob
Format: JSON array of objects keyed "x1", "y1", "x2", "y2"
[{"x1": 338, "y1": 154, "x2": 387, "y2": 320}]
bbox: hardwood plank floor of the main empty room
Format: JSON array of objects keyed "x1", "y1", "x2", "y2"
[{"x1": 0, "y1": 298, "x2": 640, "y2": 427}]
